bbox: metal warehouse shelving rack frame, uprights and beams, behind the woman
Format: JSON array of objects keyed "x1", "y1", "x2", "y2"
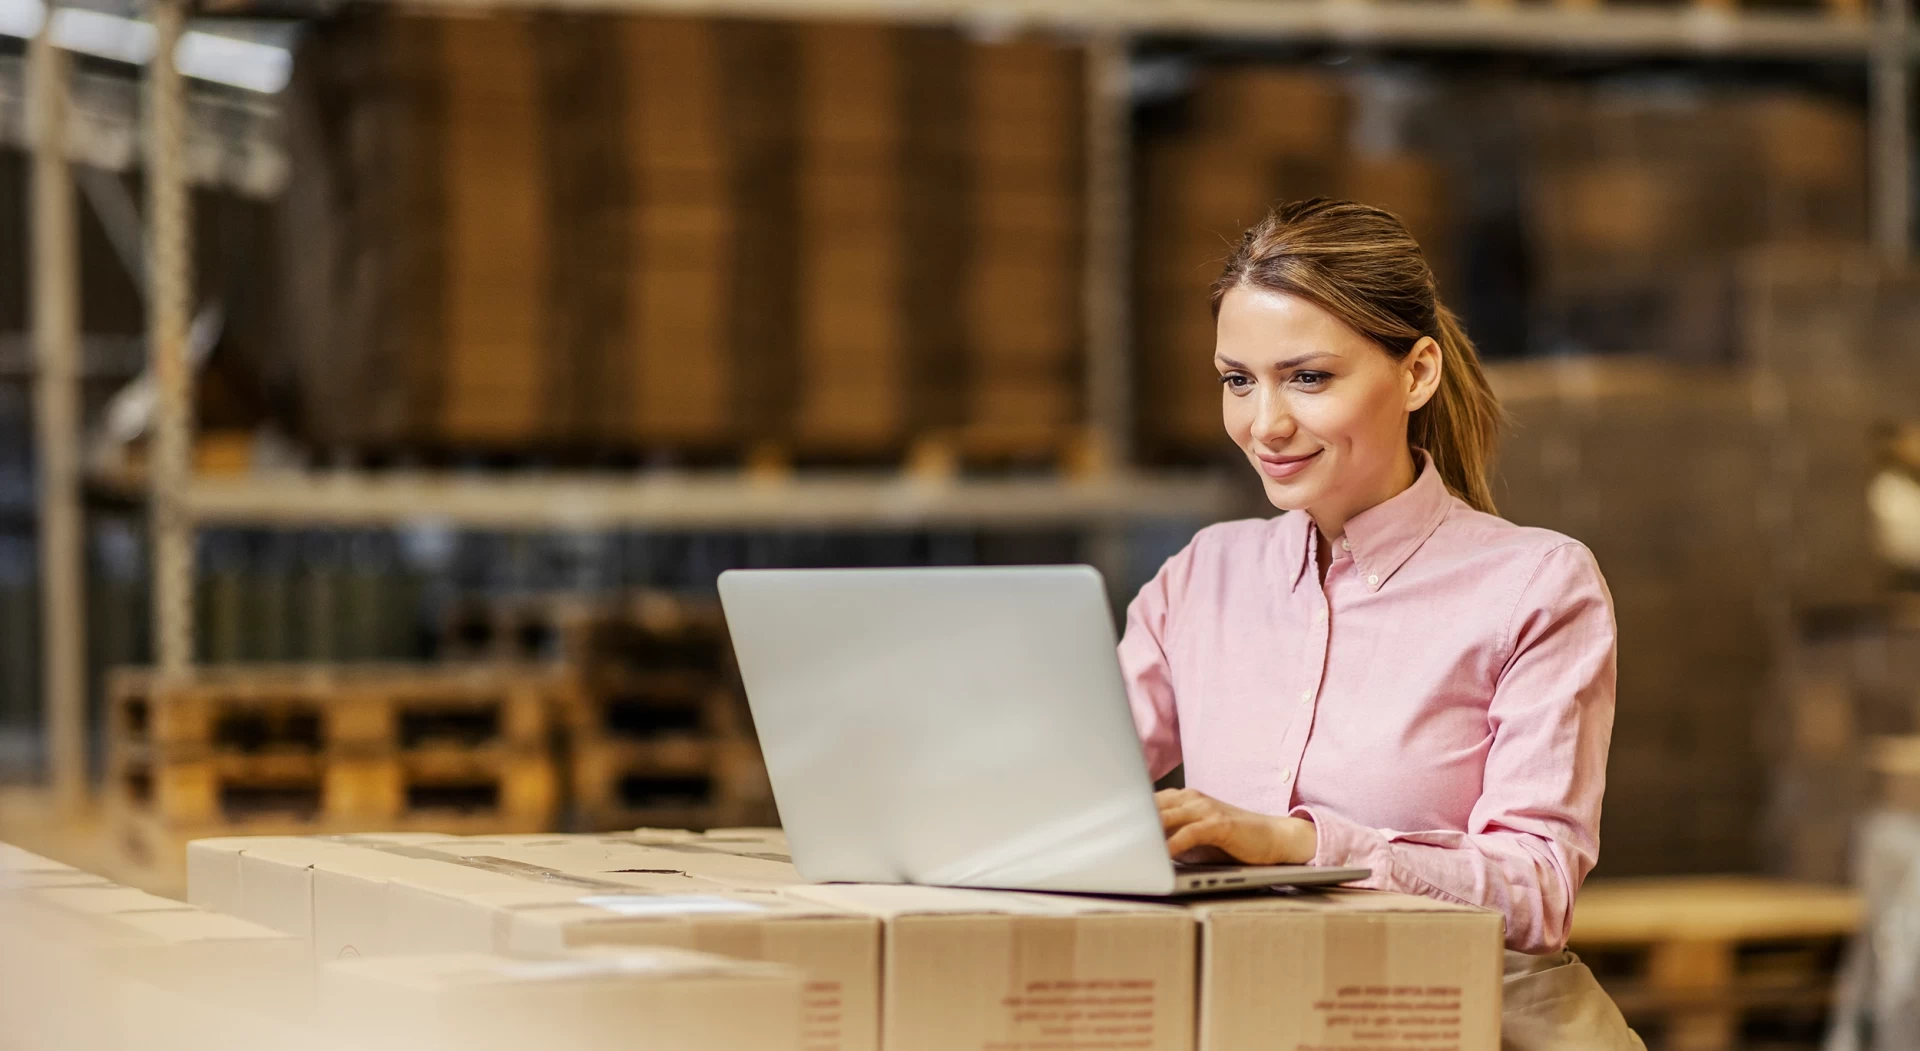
[{"x1": 18, "y1": 0, "x2": 1916, "y2": 805}]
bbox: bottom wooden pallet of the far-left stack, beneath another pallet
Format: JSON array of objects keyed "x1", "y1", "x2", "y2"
[{"x1": 106, "y1": 745, "x2": 559, "y2": 836}]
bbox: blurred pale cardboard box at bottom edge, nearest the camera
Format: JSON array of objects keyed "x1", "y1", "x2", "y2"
[{"x1": 321, "y1": 949, "x2": 801, "y2": 1051}]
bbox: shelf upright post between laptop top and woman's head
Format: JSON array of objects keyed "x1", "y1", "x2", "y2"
[{"x1": 1083, "y1": 31, "x2": 1133, "y2": 590}]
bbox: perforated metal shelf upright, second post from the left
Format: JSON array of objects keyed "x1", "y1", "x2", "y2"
[{"x1": 146, "y1": 0, "x2": 194, "y2": 674}]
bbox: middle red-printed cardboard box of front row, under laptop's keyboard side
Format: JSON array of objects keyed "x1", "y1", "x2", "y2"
[{"x1": 781, "y1": 884, "x2": 1190, "y2": 1051}]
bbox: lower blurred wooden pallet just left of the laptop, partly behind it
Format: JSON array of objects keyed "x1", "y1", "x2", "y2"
[{"x1": 572, "y1": 738, "x2": 774, "y2": 830}]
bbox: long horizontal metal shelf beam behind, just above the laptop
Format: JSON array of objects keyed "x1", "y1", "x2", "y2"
[{"x1": 184, "y1": 471, "x2": 1244, "y2": 530}]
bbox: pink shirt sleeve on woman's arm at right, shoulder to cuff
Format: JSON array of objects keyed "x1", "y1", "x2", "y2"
[{"x1": 1292, "y1": 542, "x2": 1615, "y2": 953}]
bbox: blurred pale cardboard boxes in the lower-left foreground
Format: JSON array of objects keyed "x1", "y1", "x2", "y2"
[{"x1": 0, "y1": 845, "x2": 803, "y2": 1051}]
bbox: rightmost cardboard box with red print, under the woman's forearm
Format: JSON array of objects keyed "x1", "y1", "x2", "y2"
[{"x1": 1187, "y1": 890, "x2": 1505, "y2": 1051}]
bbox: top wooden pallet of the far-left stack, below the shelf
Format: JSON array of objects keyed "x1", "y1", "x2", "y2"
[{"x1": 108, "y1": 665, "x2": 572, "y2": 759}]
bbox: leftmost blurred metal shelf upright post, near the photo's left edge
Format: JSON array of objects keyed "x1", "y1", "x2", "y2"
[{"x1": 27, "y1": 6, "x2": 86, "y2": 813}]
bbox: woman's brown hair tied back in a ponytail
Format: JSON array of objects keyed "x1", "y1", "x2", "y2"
[{"x1": 1213, "y1": 198, "x2": 1501, "y2": 515}]
